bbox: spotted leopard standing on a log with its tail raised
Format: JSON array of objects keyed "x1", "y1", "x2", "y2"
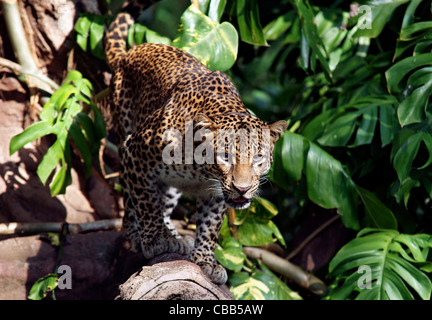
[{"x1": 105, "y1": 7, "x2": 287, "y2": 285}]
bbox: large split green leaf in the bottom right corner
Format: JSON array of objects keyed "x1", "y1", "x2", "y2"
[{"x1": 329, "y1": 229, "x2": 432, "y2": 300}]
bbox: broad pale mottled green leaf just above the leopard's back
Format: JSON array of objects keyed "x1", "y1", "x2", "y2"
[{"x1": 173, "y1": 5, "x2": 238, "y2": 71}]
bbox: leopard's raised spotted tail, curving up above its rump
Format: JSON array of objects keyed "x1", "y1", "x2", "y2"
[{"x1": 105, "y1": 12, "x2": 134, "y2": 69}]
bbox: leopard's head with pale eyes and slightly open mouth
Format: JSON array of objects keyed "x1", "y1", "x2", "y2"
[{"x1": 195, "y1": 112, "x2": 287, "y2": 209}]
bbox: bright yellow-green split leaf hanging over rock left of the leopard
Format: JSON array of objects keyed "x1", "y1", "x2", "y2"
[{"x1": 10, "y1": 70, "x2": 106, "y2": 196}]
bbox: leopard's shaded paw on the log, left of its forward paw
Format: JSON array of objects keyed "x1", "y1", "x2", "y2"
[{"x1": 141, "y1": 237, "x2": 193, "y2": 259}]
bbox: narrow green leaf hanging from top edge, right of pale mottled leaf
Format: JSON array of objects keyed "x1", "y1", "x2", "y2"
[{"x1": 236, "y1": 0, "x2": 268, "y2": 46}]
